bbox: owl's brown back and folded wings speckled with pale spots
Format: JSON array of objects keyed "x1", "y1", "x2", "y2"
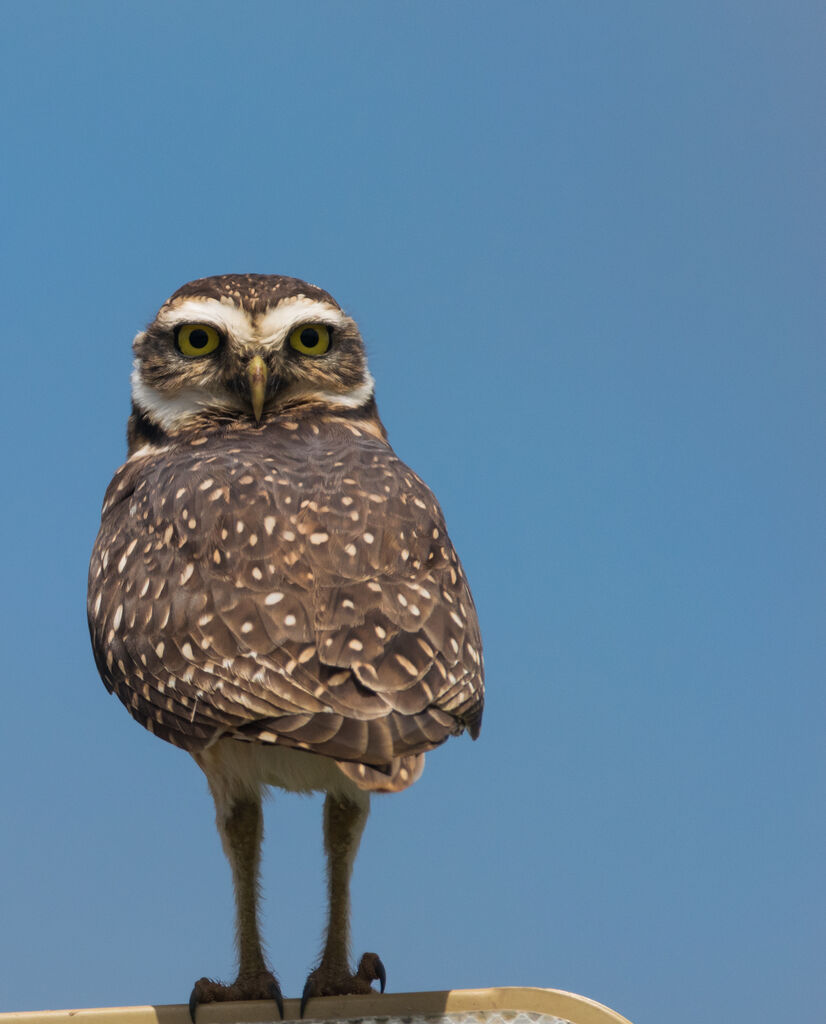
[{"x1": 89, "y1": 425, "x2": 483, "y2": 770}]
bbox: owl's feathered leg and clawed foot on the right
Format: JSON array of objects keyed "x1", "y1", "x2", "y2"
[{"x1": 301, "y1": 793, "x2": 387, "y2": 1017}]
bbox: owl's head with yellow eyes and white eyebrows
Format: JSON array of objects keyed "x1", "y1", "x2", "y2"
[{"x1": 130, "y1": 274, "x2": 375, "y2": 446}]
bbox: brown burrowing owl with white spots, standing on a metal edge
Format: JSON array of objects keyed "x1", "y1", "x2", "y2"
[{"x1": 88, "y1": 274, "x2": 483, "y2": 1019}]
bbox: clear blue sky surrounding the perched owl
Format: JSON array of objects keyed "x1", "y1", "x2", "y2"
[{"x1": 0, "y1": 0, "x2": 826, "y2": 1024}]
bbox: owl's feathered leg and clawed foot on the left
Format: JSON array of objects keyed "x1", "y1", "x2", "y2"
[{"x1": 189, "y1": 758, "x2": 284, "y2": 1024}]
